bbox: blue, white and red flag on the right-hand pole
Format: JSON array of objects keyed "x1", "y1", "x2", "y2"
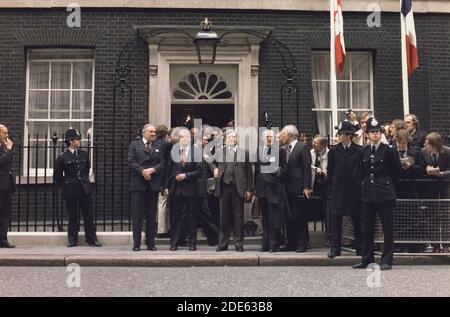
[{"x1": 401, "y1": 0, "x2": 419, "y2": 77}]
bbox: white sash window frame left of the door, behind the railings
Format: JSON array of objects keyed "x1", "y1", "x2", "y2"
[{"x1": 21, "y1": 49, "x2": 95, "y2": 178}]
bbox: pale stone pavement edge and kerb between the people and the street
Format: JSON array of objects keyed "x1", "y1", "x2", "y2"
[{"x1": 0, "y1": 251, "x2": 450, "y2": 269}]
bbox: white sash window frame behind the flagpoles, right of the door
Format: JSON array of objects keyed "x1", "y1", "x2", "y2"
[{"x1": 311, "y1": 51, "x2": 374, "y2": 131}]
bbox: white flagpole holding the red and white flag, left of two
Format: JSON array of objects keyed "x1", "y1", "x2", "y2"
[{"x1": 330, "y1": 0, "x2": 338, "y2": 131}]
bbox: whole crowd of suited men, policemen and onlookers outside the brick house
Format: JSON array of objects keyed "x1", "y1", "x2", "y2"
[{"x1": 0, "y1": 111, "x2": 450, "y2": 269}]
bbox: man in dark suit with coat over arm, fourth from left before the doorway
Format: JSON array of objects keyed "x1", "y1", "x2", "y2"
[{"x1": 254, "y1": 130, "x2": 288, "y2": 252}]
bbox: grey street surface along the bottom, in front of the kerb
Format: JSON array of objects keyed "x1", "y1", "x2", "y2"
[{"x1": 0, "y1": 265, "x2": 450, "y2": 297}]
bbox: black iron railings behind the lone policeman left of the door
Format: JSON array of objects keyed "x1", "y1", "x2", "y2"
[{"x1": 10, "y1": 134, "x2": 131, "y2": 231}]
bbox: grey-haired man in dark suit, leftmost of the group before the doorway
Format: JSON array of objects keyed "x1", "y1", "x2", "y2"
[{"x1": 128, "y1": 123, "x2": 165, "y2": 251}]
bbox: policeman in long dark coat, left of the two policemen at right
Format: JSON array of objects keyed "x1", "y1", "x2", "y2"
[{"x1": 328, "y1": 121, "x2": 362, "y2": 258}]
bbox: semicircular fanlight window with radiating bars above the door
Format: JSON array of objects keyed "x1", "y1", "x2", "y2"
[{"x1": 172, "y1": 71, "x2": 234, "y2": 101}]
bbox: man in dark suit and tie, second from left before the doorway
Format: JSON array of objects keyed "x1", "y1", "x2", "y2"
[{"x1": 164, "y1": 128, "x2": 203, "y2": 251}]
